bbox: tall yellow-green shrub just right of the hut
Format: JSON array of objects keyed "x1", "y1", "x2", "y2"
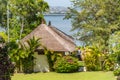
[{"x1": 84, "y1": 47, "x2": 101, "y2": 71}]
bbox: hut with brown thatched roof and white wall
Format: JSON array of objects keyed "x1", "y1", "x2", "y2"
[{"x1": 21, "y1": 24, "x2": 76, "y2": 72}]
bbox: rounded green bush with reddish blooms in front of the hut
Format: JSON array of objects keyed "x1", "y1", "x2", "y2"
[{"x1": 54, "y1": 56, "x2": 79, "y2": 73}]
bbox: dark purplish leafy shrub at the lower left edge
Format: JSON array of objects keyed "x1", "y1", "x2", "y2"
[{"x1": 0, "y1": 38, "x2": 14, "y2": 80}]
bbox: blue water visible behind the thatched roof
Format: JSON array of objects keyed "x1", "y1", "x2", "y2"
[{"x1": 44, "y1": 15, "x2": 82, "y2": 45}]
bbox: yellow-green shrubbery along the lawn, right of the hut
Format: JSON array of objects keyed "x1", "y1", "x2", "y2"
[{"x1": 83, "y1": 46, "x2": 116, "y2": 71}]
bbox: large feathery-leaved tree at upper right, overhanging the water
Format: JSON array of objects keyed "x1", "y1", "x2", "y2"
[{"x1": 66, "y1": 0, "x2": 120, "y2": 52}]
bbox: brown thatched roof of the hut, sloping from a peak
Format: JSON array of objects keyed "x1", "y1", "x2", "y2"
[{"x1": 21, "y1": 24, "x2": 76, "y2": 52}]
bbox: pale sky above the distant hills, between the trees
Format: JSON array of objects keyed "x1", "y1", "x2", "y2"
[{"x1": 44, "y1": 0, "x2": 71, "y2": 7}]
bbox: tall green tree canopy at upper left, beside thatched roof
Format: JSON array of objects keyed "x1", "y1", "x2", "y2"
[{"x1": 0, "y1": 0, "x2": 49, "y2": 39}]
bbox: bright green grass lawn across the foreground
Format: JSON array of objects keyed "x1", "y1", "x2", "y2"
[{"x1": 12, "y1": 72, "x2": 116, "y2": 80}]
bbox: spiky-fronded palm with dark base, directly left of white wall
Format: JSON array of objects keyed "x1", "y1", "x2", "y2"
[{"x1": 22, "y1": 37, "x2": 41, "y2": 73}]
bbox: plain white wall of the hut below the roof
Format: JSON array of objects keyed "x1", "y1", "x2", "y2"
[{"x1": 34, "y1": 53, "x2": 49, "y2": 72}]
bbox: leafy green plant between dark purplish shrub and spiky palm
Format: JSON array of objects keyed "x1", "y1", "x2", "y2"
[{"x1": 7, "y1": 41, "x2": 28, "y2": 72}]
